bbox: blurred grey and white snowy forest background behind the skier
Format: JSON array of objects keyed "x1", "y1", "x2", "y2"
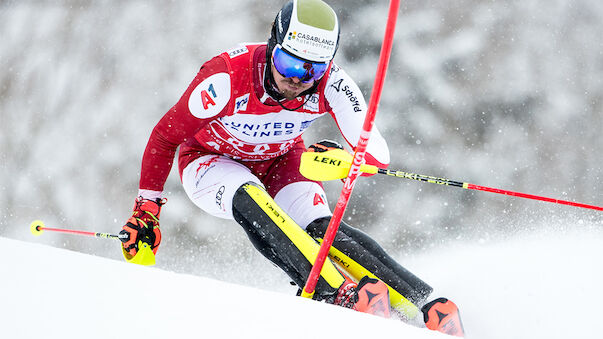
[{"x1": 0, "y1": 0, "x2": 603, "y2": 287}]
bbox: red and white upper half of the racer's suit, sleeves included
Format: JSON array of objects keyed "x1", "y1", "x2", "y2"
[{"x1": 139, "y1": 44, "x2": 389, "y2": 199}]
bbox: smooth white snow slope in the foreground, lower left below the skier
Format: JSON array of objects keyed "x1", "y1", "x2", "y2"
[{"x1": 0, "y1": 238, "x2": 447, "y2": 339}]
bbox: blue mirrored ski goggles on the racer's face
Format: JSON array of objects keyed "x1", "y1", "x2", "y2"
[{"x1": 272, "y1": 45, "x2": 329, "y2": 83}]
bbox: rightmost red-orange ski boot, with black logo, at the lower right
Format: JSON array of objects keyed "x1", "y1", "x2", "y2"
[{"x1": 421, "y1": 298, "x2": 465, "y2": 337}]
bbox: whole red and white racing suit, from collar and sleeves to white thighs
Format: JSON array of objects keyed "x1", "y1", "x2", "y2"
[{"x1": 139, "y1": 44, "x2": 389, "y2": 228}]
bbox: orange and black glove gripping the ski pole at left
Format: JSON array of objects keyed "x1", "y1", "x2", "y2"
[{"x1": 119, "y1": 197, "x2": 166, "y2": 256}]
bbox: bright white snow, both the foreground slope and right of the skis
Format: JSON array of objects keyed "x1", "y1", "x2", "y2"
[{"x1": 0, "y1": 225, "x2": 603, "y2": 339}]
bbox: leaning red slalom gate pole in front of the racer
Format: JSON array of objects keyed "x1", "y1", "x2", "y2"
[{"x1": 301, "y1": 0, "x2": 400, "y2": 298}]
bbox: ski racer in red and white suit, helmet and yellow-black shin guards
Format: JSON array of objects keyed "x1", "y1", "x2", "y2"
[{"x1": 120, "y1": 0, "x2": 468, "y2": 334}]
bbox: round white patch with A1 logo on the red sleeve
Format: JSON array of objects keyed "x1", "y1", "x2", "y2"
[{"x1": 188, "y1": 73, "x2": 230, "y2": 119}]
